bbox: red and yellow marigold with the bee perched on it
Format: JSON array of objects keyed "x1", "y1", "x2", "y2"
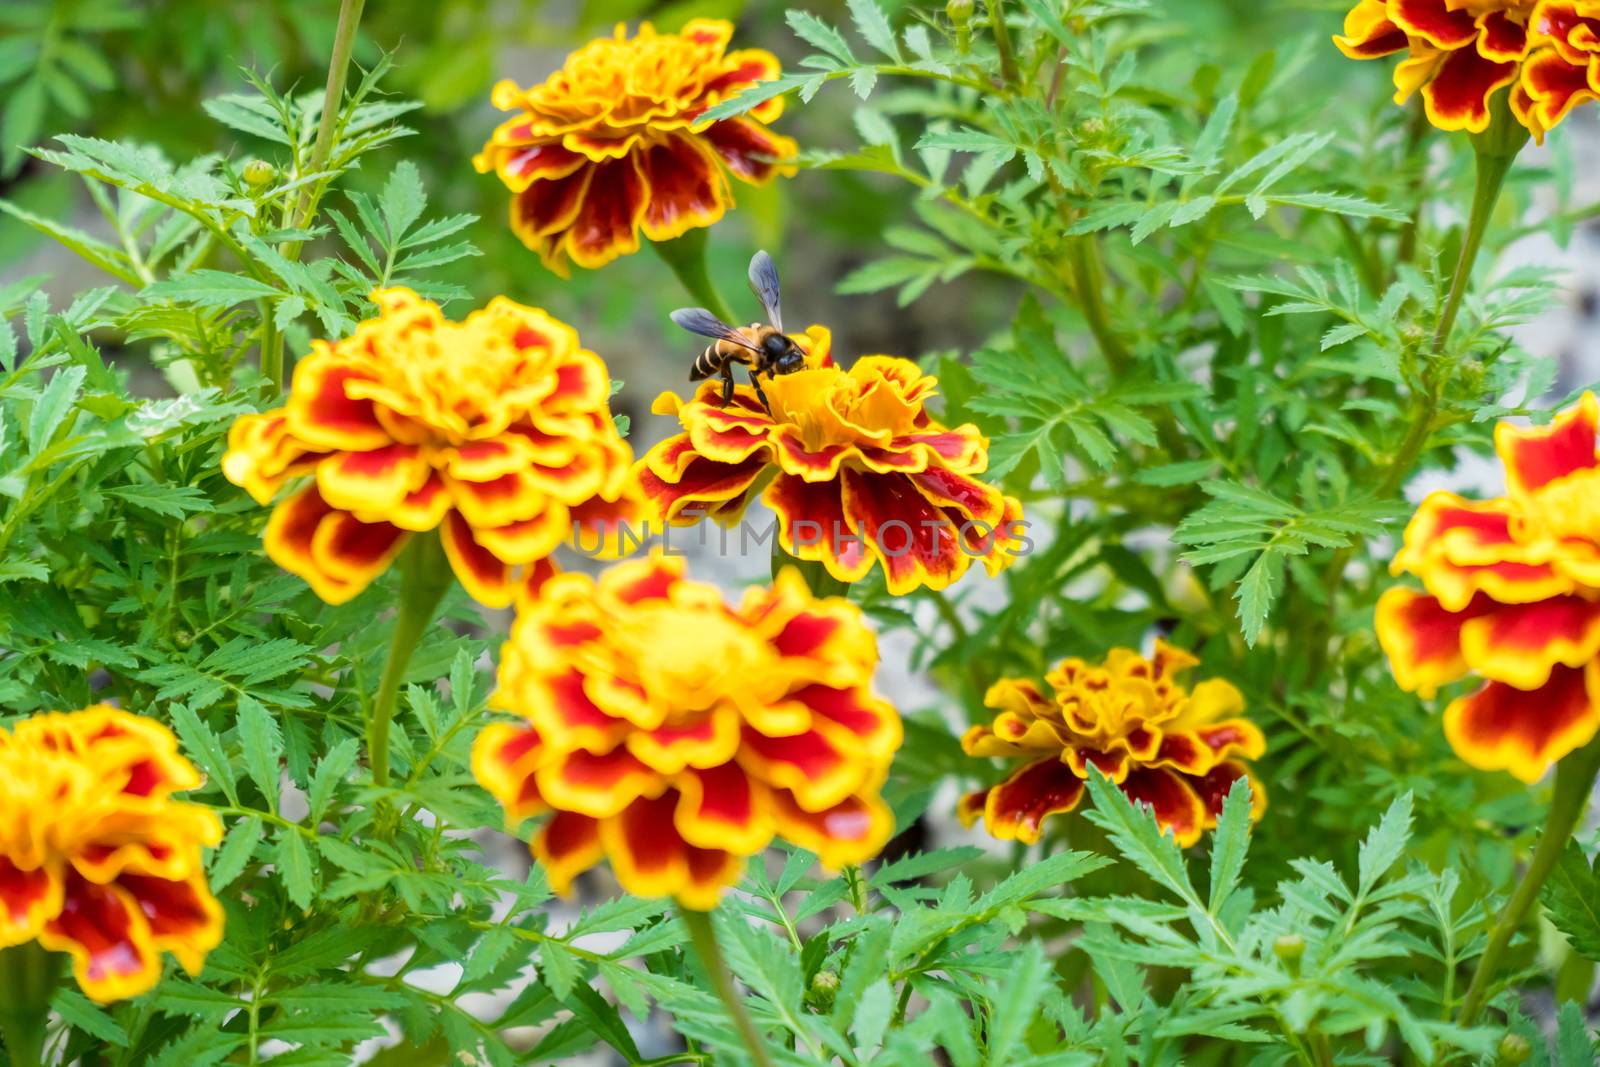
[{"x1": 638, "y1": 326, "x2": 1022, "y2": 595}]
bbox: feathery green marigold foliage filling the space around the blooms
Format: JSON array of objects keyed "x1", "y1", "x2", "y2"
[{"x1": 0, "y1": 0, "x2": 1600, "y2": 1067}]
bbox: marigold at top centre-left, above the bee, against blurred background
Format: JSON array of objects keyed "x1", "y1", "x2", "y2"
[{"x1": 472, "y1": 19, "x2": 797, "y2": 274}]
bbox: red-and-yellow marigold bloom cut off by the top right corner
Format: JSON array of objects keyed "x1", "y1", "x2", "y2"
[{"x1": 1333, "y1": 0, "x2": 1600, "y2": 141}]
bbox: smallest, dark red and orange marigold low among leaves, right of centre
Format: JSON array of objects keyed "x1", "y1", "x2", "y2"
[{"x1": 958, "y1": 641, "x2": 1267, "y2": 848}]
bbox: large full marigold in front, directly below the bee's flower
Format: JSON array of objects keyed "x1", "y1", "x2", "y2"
[{"x1": 472, "y1": 555, "x2": 901, "y2": 910}]
